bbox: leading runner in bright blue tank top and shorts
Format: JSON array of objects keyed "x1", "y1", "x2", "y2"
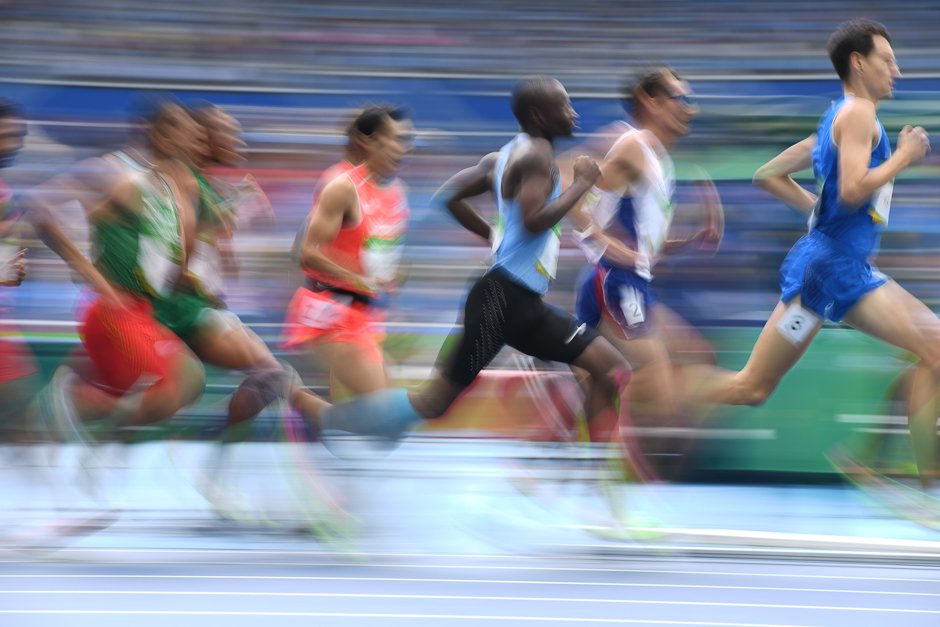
[{"x1": 699, "y1": 20, "x2": 940, "y2": 488}]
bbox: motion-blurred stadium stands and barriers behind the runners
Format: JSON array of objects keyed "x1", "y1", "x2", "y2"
[{"x1": 0, "y1": 0, "x2": 940, "y2": 479}]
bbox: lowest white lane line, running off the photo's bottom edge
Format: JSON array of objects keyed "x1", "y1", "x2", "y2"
[{"x1": 0, "y1": 610, "x2": 824, "y2": 627}]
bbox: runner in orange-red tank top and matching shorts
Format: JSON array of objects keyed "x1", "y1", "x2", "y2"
[{"x1": 285, "y1": 105, "x2": 413, "y2": 401}]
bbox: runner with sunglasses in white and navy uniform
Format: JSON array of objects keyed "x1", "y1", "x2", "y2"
[{"x1": 577, "y1": 67, "x2": 723, "y2": 472}]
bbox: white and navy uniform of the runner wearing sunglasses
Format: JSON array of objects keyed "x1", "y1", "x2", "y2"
[{"x1": 577, "y1": 125, "x2": 675, "y2": 338}]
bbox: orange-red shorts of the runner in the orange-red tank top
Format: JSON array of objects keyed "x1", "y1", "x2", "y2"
[{"x1": 284, "y1": 287, "x2": 384, "y2": 362}]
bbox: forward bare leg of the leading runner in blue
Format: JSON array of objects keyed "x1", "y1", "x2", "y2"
[{"x1": 845, "y1": 281, "x2": 940, "y2": 487}]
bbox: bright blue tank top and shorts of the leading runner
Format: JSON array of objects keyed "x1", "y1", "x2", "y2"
[{"x1": 780, "y1": 96, "x2": 893, "y2": 321}]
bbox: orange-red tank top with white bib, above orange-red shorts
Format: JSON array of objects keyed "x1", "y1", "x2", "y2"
[{"x1": 304, "y1": 161, "x2": 408, "y2": 293}]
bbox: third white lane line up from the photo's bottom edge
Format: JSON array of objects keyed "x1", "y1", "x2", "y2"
[{"x1": 0, "y1": 571, "x2": 940, "y2": 597}]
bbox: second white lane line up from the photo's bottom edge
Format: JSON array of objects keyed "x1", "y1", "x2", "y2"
[{"x1": 6, "y1": 590, "x2": 940, "y2": 614}]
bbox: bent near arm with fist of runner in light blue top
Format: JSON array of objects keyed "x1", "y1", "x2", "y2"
[{"x1": 501, "y1": 138, "x2": 600, "y2": 233}]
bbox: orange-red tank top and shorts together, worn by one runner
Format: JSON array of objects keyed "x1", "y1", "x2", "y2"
[{"x1": 285, "y1": 162, "x2": 408, "y2": 360}]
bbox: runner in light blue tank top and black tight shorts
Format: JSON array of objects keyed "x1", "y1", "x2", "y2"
[{"x1": 319, "y1": 77, "x2": 629, "y2": 462}]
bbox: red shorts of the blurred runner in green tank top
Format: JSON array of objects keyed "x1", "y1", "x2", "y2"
[{"x1": 79, "y1": 299, "x2": 184, "y2": 393}]
